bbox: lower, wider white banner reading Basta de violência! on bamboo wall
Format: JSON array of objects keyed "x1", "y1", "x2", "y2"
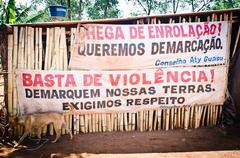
[{"x1": 17, "y1": 65, "x2": 227, "y2": 114}]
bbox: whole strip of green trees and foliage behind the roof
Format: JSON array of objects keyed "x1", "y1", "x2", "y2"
[{"x1": 0, "y1": 0, "x2": 240, "y2": 24}]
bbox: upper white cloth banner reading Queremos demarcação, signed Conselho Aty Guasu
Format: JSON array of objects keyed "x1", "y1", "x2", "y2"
[{"x1": 70, "y1": 21, "x2": 229, "y2": 70}]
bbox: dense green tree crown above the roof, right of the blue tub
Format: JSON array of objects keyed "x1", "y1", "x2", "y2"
[{"x1": 87, "y1": 0, "x2": 120, "y2": 19}]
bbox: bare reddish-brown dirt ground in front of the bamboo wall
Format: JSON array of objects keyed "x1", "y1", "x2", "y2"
[{"x1": 0, "y1": 125, "x2": 240, "y2": 158}]
